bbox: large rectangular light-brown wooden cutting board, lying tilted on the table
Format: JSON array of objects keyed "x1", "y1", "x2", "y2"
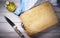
[{"x1": 20, "y1": 2, "x2": 58, "y2": 36}]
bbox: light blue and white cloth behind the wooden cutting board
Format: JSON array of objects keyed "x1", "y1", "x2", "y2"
[{"x1": 14, "y1": 0, "x2": 37, "y2": 15}]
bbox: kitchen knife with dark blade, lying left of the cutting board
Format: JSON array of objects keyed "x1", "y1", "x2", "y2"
[{"x1": 4, "y1": 16, "x2": 30, "y2": 38}]
